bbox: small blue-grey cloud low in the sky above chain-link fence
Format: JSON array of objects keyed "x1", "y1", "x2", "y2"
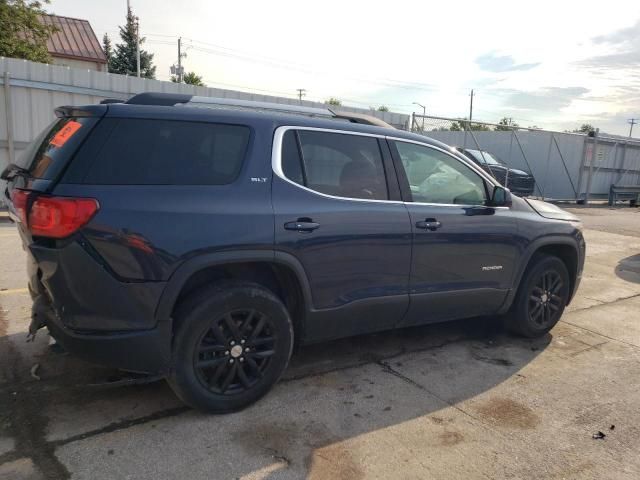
[{"x1": 501, "y1": 87, "x2": 590, "y2": 111}]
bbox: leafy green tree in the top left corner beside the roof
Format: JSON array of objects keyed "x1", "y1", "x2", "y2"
[{"x1": 0, "y1": 0, "x2": 58, "y2": 63}]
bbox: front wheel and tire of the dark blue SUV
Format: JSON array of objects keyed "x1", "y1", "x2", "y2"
[{"x1": 505, "y1": 254, "x2": 570, "y2": 338}]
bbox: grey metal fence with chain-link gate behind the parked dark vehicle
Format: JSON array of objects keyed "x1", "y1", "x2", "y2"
[{"x1": 412, "y1": 114, "x2": 640, "y2": 201}]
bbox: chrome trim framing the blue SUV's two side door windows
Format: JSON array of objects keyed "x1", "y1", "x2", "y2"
[{"x1": 271, "y1": 125, "x2": 509, "y2": 210}]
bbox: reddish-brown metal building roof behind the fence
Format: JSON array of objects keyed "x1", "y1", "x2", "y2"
[{"x1": 40, "y1": 15, "x2": 107, "y2": 63}]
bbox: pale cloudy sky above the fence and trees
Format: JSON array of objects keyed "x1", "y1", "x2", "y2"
[{"x1": 46, "y1": 0, "x2": 640, "y2": 138}]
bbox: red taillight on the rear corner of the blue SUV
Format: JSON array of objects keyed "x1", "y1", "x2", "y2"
[{"x1": 28, "y1": 197, "x2": 99, "y2": 238}]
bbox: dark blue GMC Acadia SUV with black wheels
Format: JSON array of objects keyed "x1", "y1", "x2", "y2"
[{"x1": 2, "y1": 94, "x2": 585, "y2": 412}]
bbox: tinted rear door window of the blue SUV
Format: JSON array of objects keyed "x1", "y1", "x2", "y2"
[{"x1": 282, "y1": 130, "x2": 389, "y2": 200}]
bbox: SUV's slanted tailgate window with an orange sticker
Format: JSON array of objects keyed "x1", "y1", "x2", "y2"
[{"x1": 16, "y1": 117, "x2": 97, "y2": 180}]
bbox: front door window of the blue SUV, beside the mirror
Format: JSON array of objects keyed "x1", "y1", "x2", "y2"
[{"x1": 395, "y1": 142, "x2": 487, "y2": 205}]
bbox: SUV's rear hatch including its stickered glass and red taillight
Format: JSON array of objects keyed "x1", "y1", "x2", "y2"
[{"x1": 1, "y1": 105, "x2": 107, "y2": 240}]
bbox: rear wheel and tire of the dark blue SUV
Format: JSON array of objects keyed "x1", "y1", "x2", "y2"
[{"x1": 167, "y1": 282, "x2": 293, "y2": 413}]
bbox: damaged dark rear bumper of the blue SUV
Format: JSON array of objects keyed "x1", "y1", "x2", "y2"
[{"x1": 26, "y1": 241, "x2": 171, "y2": 374}]
